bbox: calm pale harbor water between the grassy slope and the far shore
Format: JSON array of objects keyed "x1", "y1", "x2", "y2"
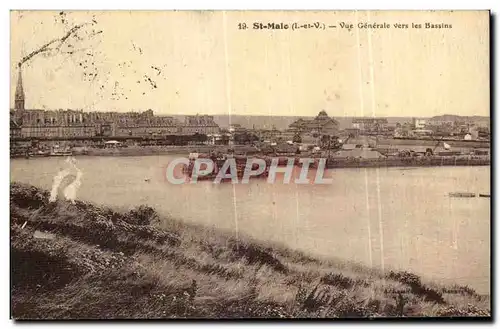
[{"x1": 10, "y1": 156, "x2": 490, "y2": 293}]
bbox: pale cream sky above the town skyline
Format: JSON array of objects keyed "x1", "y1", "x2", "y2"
[{"x1": 11, "y1": 11, "x2": 490, "y2": 117}]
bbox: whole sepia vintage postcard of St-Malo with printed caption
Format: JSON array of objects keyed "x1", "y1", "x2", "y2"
[{"x1": 10, "y1": 10, "x2": 492, "y2": 320}]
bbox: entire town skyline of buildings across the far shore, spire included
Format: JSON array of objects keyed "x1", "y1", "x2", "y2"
[{"x1": 10, "y1": 66, "x2": 490, "y2": 143}]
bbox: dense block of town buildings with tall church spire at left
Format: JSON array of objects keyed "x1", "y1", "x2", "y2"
[{"x1": 10, "y1": 69, "x2": 219, "y2": 139}]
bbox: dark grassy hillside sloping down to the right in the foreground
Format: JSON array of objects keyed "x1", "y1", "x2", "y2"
[{"x1": 10, "y1": 184, "x2": 490, "y2": 319}]
